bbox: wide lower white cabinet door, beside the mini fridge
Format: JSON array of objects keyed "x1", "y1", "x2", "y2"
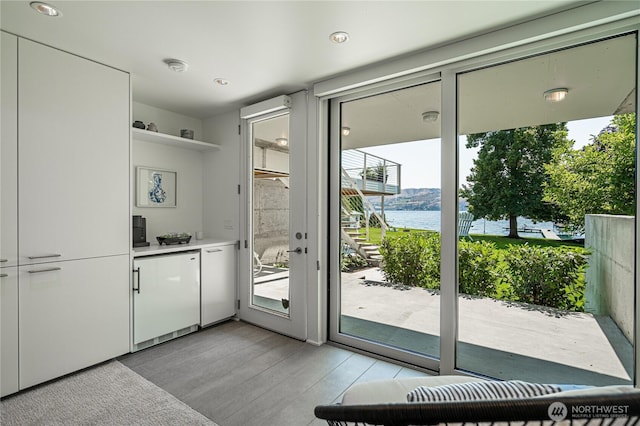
[{"x1": 19, "y1": 255, "x2": 131, "y2": 389}]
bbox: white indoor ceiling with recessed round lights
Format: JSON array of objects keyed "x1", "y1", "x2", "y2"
[{"x1": 0, "y1": 0, "x2": 585, "y2": 118}]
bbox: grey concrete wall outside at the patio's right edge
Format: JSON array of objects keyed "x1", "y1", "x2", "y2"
[{"x1": 585, "y1": 215, "x2": 635, "y2": 341}]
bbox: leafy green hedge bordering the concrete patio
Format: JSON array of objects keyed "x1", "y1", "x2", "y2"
[{"x1": 380, "y1": 233, "x2": 587, "y2": 311}]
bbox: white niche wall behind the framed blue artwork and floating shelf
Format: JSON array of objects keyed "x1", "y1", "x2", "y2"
[{"x1": 131, "y1": 102, "x2": 203, "y2": 240}]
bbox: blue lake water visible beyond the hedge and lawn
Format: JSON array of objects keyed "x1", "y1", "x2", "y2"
[{"x1": 384, "y1": 210, "x2": 553, "y2": 238}]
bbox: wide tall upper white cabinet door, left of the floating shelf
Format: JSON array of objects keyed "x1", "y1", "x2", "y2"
[{"x1": 18, "y1": 39, "x2": 131, "y2": 264}]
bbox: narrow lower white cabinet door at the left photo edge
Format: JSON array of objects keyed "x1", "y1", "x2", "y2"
[{"x1": 0, "y1": 267, "x2": 18, "y2": 397}]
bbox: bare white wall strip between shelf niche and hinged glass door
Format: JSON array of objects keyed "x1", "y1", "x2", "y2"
[{"x1": 202, "y1": 111, "x2": 240, "y2": 240}]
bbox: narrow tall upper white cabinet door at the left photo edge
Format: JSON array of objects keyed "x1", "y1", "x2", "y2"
[{"x1": 0, "y1": 33, "x2": 18, "y2": 267}]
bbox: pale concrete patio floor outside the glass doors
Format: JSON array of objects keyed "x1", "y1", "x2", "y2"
[{"x1": 256, "y1": 268, "x2": 633, "y2": 385}]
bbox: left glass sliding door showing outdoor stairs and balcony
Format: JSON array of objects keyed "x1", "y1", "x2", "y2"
[{"x1": 331, "y1": 81, "x2": 441, "y2": 369}]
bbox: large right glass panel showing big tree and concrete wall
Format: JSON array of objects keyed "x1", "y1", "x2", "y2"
[{"x1": 456, "y1": 34, "x2": 637, "y2": 385}]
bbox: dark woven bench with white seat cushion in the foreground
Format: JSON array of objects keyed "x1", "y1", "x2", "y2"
[{"x1": 315, "y1": 376, "x2": 640, "y2": 426}]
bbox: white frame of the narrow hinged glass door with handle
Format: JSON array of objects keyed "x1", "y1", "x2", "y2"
[{"x1": 238, "y1": 92, "x2": 310, "y2": 340}]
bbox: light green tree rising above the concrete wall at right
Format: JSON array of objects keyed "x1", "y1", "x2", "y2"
[{"x1": 543, "y1": 114, "x2": 636, "y2": 231}]
